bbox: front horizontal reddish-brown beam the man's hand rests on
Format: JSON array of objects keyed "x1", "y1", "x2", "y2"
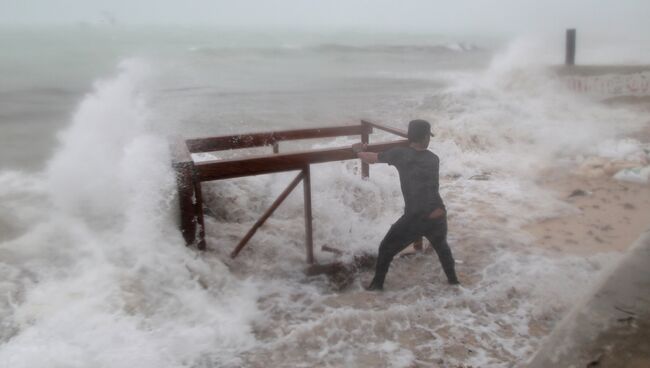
[{"x1": 195, "y1": 140, "x2": 408, "y2": 181}]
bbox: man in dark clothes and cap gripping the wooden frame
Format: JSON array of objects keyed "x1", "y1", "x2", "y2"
[{"x1": 352, "y1": 120, "x2": 459, "y2": 290}]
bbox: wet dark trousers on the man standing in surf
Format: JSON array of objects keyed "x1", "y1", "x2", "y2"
[{"x1": 372, "y1": 215, "x2": 457, "y2": 288}]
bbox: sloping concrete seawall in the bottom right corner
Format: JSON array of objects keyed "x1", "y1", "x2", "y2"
[{"x1": 525, "y1": 231, "x2": 650, "y2": 368}]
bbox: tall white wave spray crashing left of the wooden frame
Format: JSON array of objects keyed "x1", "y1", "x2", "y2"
[{"x1": 0, "y1": 60, "x2": 257, "y2": 367}]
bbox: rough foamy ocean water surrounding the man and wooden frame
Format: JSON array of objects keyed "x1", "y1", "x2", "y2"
[{"x1": 0, "y1": 27, "x2": 647, "y2": 367}]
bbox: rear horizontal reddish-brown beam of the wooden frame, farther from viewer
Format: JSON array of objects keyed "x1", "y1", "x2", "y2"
[{"x1": 187, "y1": 125, "x2": 363, "y2": 153}]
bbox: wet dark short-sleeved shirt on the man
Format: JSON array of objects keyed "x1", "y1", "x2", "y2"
[{"x1": 378, "y1": 147, "x2": 445, "y2": 215}]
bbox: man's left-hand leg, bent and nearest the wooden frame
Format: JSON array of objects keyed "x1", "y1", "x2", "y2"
[{"x1": 368, "y1": 216, "x2": 421, "y2": 290}]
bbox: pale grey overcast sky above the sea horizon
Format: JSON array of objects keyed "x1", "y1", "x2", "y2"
[{"x1": 0, "y1": 0, "x2": 650, "y2": 34}]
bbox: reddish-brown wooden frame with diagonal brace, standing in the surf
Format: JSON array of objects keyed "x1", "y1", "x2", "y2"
[{"x1": 172, "y1": 120, "x2": 408, "y2": 264}]
